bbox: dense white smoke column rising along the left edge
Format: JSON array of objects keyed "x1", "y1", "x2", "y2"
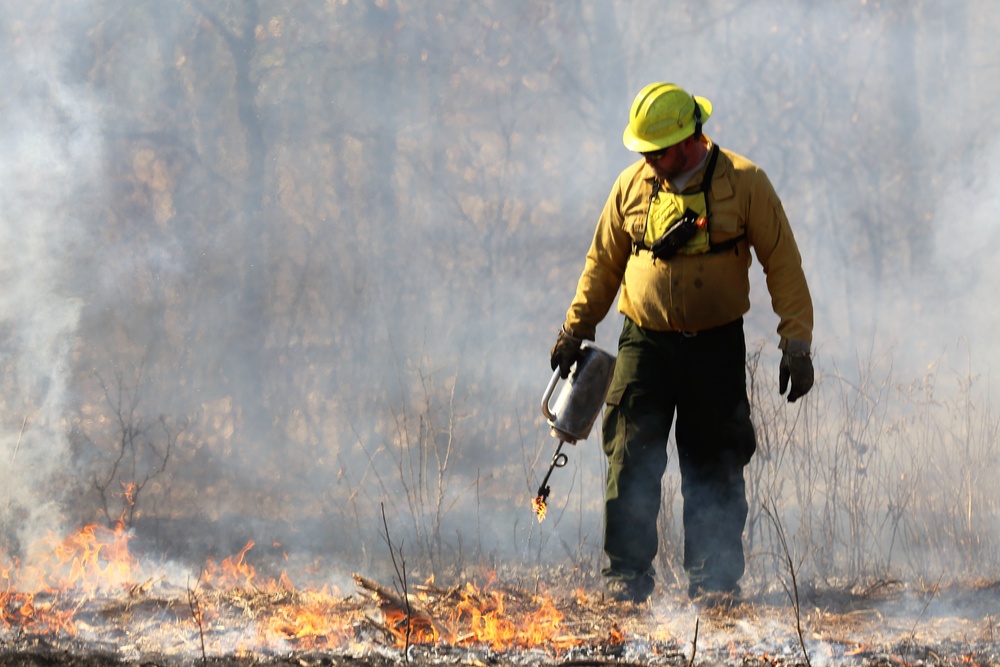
[{"x1": 0, "y1": 5, "x2": 103, "y2": 546}]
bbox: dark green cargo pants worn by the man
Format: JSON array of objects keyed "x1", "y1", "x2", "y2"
[{"x1": 603, "y1": 319, "x2": 757, "y2": 590}]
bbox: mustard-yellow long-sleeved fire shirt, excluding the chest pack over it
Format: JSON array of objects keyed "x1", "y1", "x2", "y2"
[{"x1": 565, "y1": 141, "x2": 813, "y2": 349}]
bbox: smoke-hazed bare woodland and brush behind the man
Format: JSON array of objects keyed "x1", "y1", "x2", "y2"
[{"x1": 0, "y1": 0, "x2": 1000, "y2": 588}]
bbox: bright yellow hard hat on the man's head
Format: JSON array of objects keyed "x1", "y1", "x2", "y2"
[{"x1": 622, "y1": 82, "x2": 712, "y2": 153}]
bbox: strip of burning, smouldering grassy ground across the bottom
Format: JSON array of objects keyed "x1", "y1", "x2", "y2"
[{"x1": 0, "y1": 526, "x2": 1000, "y2": 666}]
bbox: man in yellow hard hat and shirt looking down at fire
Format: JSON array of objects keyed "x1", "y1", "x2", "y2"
[{"x1": 551, "y1": 82, "x2": 813, "y2": 602}]
